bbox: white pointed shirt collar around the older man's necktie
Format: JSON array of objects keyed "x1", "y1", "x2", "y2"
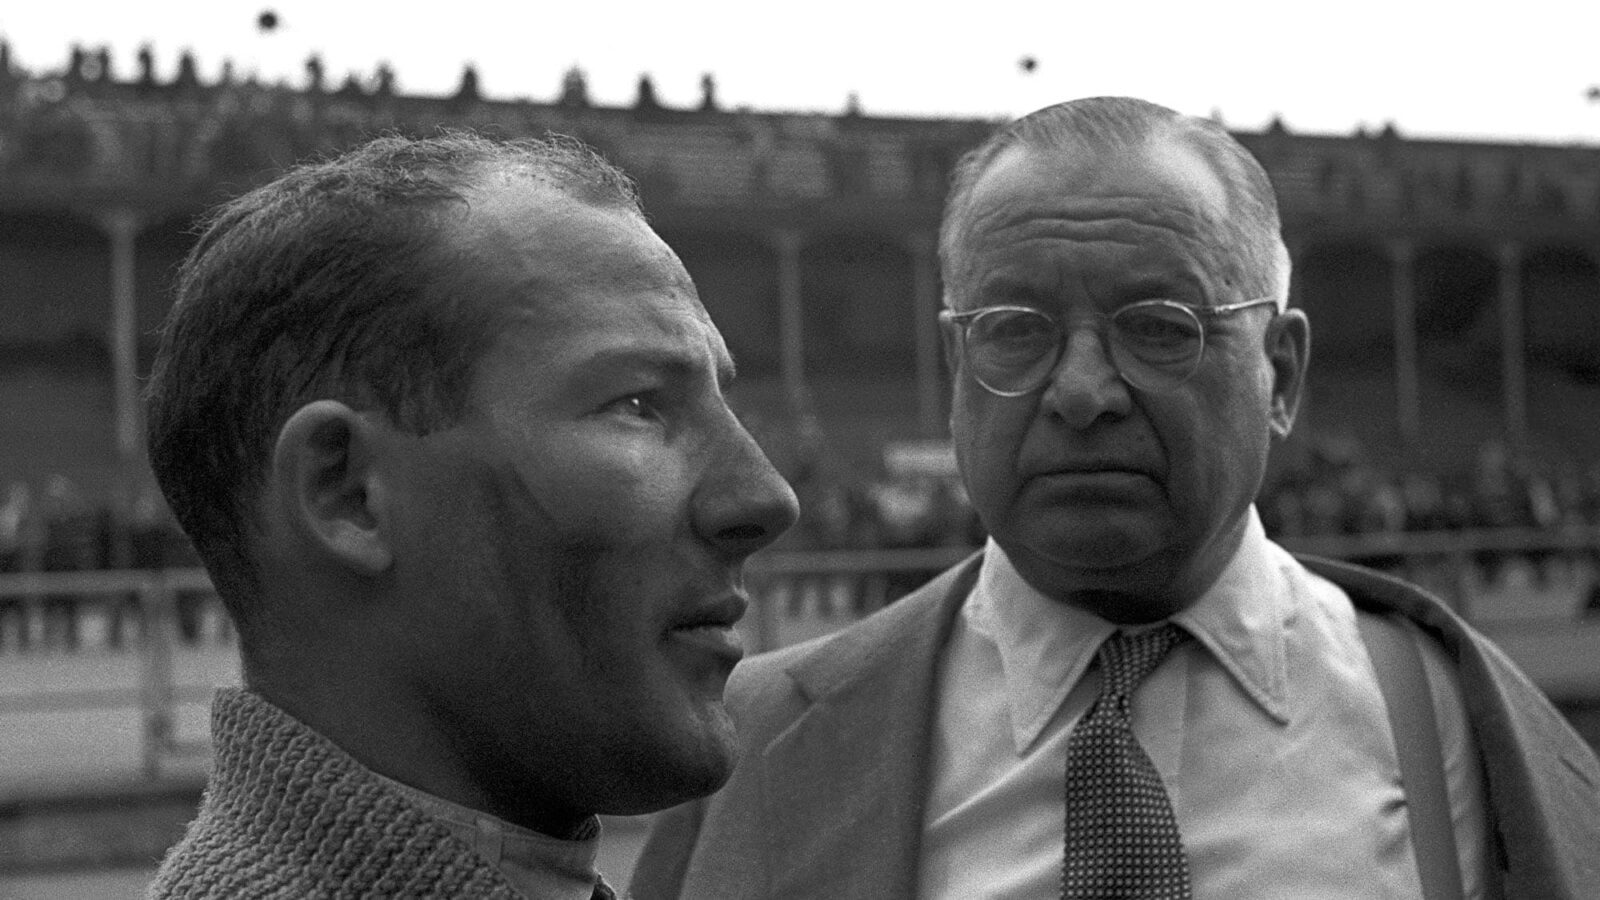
[{"x1": 962, "y1": 508, "x2": 1290, "y2": 754}]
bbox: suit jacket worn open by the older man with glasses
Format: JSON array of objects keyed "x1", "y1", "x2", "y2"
[{"x1": 630, "y1": 556, "x2": 1600, "y2": 900}]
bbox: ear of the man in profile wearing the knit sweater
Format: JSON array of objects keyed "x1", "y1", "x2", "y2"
[{"x1": 267, "y1": 400, "x2": 394, "y2": 575}]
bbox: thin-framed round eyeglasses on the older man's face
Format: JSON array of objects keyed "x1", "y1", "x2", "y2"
[{"x1": 939, "y1": 296, "x2": 1277, "y2": 397}]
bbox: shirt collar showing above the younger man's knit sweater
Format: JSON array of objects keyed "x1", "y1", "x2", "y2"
[{"x1": 378, "y1": 775, "x2": 600, "y2": 900}]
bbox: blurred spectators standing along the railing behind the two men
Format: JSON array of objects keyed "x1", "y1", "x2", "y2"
[{"x1": 0, "y1": 439, "x2": 1600, "y2": 652}]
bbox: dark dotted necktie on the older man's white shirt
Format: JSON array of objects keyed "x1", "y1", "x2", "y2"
[{"x1": 1061, "y1": 623, "x2": 1192, "y2": 900}]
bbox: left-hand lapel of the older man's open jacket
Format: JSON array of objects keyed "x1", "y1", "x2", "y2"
[{"x1": 762, "y1": 556, "x2": 981, "y2": 898}]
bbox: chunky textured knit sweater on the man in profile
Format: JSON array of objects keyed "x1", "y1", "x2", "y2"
[{"x1": 149, "y1": 689, "x2": 611, "y2": 900}]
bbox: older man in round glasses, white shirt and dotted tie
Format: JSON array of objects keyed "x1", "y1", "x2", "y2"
[{"x1": 634, "y1": 98, "x2": 1600, "y2": 900}]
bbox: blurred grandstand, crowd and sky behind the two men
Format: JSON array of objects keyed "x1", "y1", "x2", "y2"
[{"x1": 0, "y1": 0, "x2": 1600, "y2": 898}]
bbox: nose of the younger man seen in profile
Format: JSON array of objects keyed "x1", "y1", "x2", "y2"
[{"x1": 694, "y1": 415, "x2": 800, "y2": 559}]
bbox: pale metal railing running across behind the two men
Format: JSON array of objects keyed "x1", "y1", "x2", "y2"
[{"x1": 0, "y1": 528, "x2": 1600, "y2": 778}]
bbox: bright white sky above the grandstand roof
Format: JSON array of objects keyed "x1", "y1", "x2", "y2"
[{"x1": 0, "y1": 0, "x2": 1600, "y2": 146}]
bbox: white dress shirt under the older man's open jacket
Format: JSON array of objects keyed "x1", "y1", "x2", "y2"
[{"x1": 918, "y1": 509, "x2": 1485, "y2": 900}]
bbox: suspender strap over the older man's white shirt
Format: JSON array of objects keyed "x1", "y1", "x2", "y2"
[{"x1": 1355, "y1": 612, "x2": 1461, "y2": 900}]
